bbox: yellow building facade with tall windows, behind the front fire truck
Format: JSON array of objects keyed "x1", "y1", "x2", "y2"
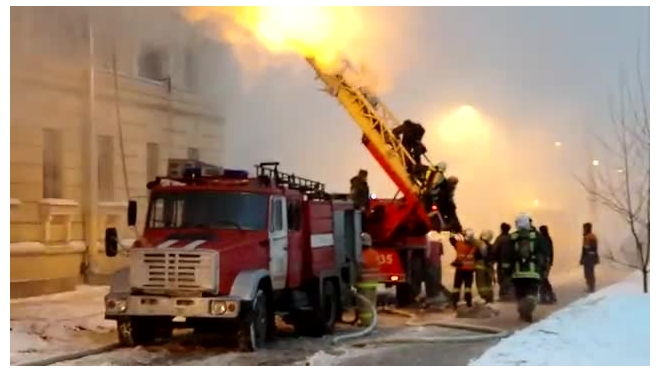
[{"x1": 10, "y1": 7, "x2": 225, "y2": 298}]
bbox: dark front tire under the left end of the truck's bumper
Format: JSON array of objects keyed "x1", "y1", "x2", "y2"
[{"x1": 117, "y1": 317, "x2": 172, "y2": 346}]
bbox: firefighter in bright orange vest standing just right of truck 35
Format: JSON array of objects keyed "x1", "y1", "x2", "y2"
[{"x1": 449, "y1": 229, "x2": 476, "y2": 309}]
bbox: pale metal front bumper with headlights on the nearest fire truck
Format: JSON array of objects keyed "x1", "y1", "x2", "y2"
[{"x1": 105, "y1": 293, "x2": 242, "y2": 319}]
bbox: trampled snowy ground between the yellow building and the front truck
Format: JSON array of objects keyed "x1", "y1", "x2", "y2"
[{"x1": 10, "y1": 286, "x2": 116, "y2": 364}]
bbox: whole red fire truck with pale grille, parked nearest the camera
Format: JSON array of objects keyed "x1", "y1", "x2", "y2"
[{"x1": 105, "y1": 160, "x2": 362, "y2": 351}]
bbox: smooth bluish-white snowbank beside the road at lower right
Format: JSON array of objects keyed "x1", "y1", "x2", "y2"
[{"x1": 470, "y1": 272, "x2": 651, "y2": 366}]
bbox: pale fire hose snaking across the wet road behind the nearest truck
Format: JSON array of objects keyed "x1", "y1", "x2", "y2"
[{"x1": 332, "y1": 290, "x2": 511, "y2": 347}]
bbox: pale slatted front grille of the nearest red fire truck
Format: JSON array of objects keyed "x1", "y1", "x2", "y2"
[{"x1": 130, "y1": 248, "x2": 219, "y2": 293}]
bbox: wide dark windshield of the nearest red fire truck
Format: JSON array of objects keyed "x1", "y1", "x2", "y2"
[{"x1": 147, "y1": 191, "x2": 268, "y2": 230}]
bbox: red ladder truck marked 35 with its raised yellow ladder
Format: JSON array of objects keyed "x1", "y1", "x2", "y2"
[{"x1": 307, "y1": 58, "x2": 456, "y2": 306}]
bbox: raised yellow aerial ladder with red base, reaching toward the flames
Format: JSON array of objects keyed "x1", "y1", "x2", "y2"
[{"x1": 307, "y1": 58, "x2": 438, "y2": 239}]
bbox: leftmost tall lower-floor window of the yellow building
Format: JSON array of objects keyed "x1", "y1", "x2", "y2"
[{"x1": 43, "y1": 129, "x2": 62, "y2": 198}]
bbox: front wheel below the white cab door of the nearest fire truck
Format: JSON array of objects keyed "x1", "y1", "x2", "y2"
[{"x1": 236, "y1": 289, "x2": 269, "y2": 352}]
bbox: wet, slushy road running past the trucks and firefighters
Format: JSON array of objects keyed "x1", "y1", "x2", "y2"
[{"x1": 57, "y1": 268, "x2": 627, "y2": 366}]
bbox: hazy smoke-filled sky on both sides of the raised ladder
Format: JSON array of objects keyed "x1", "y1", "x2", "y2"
[{"x1": 201, "y1": 7, "x2": 650, "y2": 247}]
